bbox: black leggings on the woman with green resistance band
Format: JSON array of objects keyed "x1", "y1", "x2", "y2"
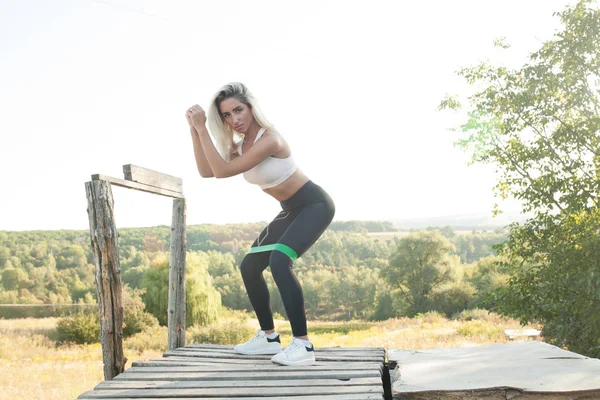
[{"x1": 240, "y1": 181, "x2": 335, "y2": 337}]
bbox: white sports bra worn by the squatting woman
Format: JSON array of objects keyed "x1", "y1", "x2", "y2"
[{"x1": 238, "y1": 128, "x2": 298, "y2": 189}]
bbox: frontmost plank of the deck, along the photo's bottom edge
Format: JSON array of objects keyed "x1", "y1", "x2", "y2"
[{"x1": 79, "y1": 386, "x2": 383, "y2": 399}]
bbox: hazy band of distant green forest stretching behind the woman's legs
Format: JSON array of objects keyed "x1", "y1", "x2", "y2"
[{"x1": 0, "y1": 221, "x2": 504, "y2": 321}]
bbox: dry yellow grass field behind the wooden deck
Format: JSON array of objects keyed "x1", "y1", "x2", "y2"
[{"x1": 0, "y1": 312, "x2": 540, "y2": 400}]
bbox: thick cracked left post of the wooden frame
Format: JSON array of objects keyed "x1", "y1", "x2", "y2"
[{"x1": 85, "y1": 181, "x2": 127, "y2": 380}]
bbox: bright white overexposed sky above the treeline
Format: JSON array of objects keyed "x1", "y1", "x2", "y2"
[{"x1": 0, "y1": 0, "x2": 572, "y2": 230}]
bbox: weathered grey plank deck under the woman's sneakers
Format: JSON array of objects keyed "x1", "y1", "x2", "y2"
[{"x1": 78, "y1": 344, "x2": 386, "y2": 400}]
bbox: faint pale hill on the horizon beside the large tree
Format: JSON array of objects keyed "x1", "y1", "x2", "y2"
[{"x1": 390, "y1": 212, "x2": 525, "y2": 230}]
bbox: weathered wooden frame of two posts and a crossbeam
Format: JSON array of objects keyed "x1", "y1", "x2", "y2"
[{"x1": 85, "y1": 164, "x2": 186, "y2": 380}]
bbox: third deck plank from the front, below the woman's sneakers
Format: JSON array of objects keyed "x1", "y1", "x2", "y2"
[{"x1": 115, "y1": 366, "x2": 381, "y2": 381}]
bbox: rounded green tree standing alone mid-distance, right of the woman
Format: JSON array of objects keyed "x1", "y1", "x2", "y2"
[{"x1": 381, "y1": 231, "x2": 459, "y2": 315}]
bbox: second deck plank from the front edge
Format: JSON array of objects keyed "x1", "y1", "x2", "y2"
[{"x1": 94, "y1": 376, "x2": 381, "y2": 390}]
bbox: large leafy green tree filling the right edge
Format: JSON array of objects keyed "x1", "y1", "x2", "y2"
[{"x1": 440, "y1": 0, "x2": 600, "y2": 357}]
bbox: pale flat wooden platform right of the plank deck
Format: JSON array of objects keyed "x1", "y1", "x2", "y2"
[{"x1": 388, "y1": 341, "x2": 600, "y2": 400}]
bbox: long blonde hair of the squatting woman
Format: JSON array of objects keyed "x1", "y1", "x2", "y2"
[{"x1": 206, "y1": 82, "x2": 274, "y2": 162}]
